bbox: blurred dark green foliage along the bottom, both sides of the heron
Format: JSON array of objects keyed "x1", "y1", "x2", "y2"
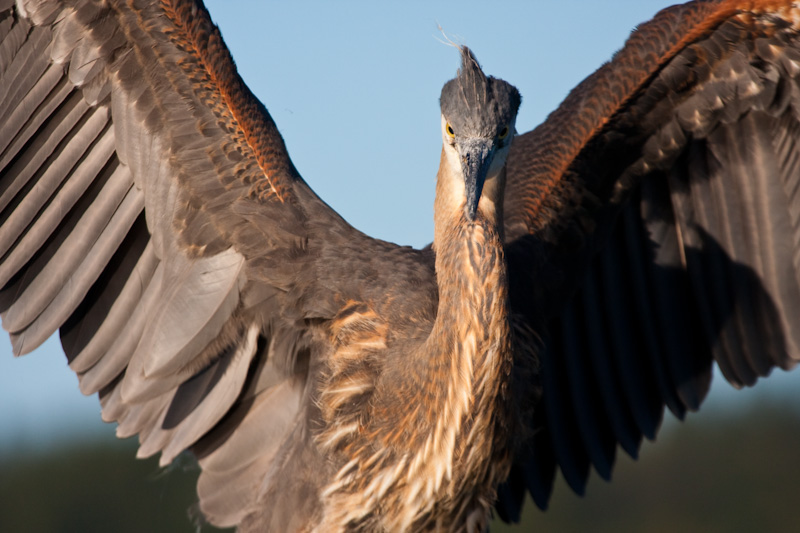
[{"x1": 0, "y1": 399, "x2": 800, "y2": 533}]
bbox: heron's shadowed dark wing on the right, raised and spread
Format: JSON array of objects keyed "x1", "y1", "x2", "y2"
[{"x1": 498, "y1": 1, "x2": 800, "y2": 519}]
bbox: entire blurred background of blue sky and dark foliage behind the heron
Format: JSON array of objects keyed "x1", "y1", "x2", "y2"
[{"x1": 0, "y1": 0, "x2": 800, "y2": 533}]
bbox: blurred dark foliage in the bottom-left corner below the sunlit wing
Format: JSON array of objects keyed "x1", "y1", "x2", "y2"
[{"x1": 0, "y1": 440, "x2": 228, "y2": 533}]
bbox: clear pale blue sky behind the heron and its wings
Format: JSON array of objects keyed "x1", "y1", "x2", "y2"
[{"x1": 0, "y1": 0, "x2": 800, "y2": 449}]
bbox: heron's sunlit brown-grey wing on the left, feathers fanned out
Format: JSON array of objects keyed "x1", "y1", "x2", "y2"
[{"x1": 0, "y1": 0, "x2": 435, "y2": 526}]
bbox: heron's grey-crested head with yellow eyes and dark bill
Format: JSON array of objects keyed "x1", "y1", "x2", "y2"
[{"x1": 439, "y1": 46, "x2": 521, "y2": 221}]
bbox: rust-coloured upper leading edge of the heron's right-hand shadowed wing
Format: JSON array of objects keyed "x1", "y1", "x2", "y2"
[{"x1": 506, "y1": 0, "x2": 796, "y2": 235}]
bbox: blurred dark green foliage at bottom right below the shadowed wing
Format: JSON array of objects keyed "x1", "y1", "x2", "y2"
[{"x1": 492, "y1": 399, "x2": 800, "y2": 533}]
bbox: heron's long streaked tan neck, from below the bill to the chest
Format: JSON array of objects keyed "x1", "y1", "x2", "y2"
[{"x1": 398, "y1": 147, "x2": 512, "y2": 516}]
